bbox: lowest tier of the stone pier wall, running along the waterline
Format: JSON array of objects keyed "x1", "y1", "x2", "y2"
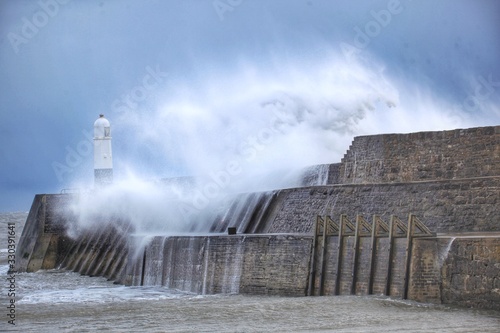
[{"x1": 17, "y1": 195, "x2": 500, "y2": 309}]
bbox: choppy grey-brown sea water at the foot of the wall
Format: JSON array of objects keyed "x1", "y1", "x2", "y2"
[{"x1": 0, "y1": 213, "x2": 500, "y2": 333}]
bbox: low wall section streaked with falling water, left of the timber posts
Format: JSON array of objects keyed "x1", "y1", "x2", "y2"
[{"x1": 127, "y1": 235, "x2": 311, "y2": 296}]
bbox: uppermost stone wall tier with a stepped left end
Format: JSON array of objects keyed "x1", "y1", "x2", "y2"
[{"x1": 328, "y1": 126, "x2": 500, "y2": 184}]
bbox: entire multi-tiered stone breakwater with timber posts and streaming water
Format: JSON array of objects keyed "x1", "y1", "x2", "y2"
[{"x1": 17, "y1": 126, "x2": 500, "y2": 309}]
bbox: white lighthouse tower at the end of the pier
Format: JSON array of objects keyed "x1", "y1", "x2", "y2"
[{"x1": 94, "y1": 114, "x2": 113, "y2": 187}]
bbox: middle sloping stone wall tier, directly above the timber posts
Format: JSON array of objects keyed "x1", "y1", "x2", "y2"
[{"x1": 262, "y1": 176, "x2": 500, "y2": 233}]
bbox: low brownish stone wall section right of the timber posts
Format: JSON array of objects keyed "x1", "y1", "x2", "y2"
[{"x1": 408, "y1": 233, "x2": 500, "y2": 310}]
